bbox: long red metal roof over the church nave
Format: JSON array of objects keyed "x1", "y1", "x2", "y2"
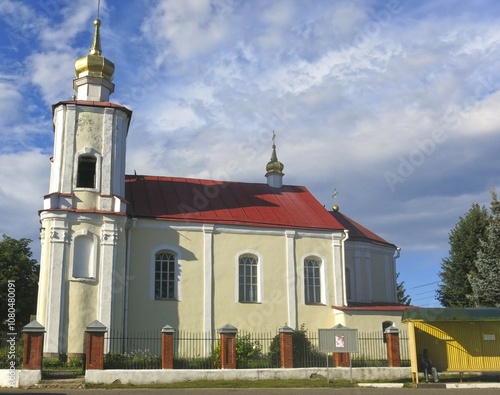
[{"x1": 125, "y1": 175, "x2": 344, "y2": 231}]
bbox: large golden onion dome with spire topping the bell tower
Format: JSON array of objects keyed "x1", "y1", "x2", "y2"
[{"x1": 75, "y1": 19, "x2": 115, "y2": 81}]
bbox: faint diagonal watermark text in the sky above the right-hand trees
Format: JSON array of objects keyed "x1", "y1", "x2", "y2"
[{"x1": 384, "y1": 129, "x2": 448, "y2": 192}]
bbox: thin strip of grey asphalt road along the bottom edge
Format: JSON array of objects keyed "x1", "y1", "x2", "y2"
[{"x1": 0, "y1": 388, "x2": 499, "y2": 395}]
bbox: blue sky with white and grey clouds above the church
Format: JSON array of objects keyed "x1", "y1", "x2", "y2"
[{"x1": 0, "y1": 0, "x2": 500, "y2": 307}]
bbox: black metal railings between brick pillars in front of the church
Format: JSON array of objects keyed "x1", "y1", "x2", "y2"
[{"x1": 104, "y1": 330, "x2": 410, "y2": 369}]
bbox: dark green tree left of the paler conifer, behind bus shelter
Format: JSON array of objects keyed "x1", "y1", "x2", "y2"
[{"x1": 436, "y1": 203, "x2": 489, "y2": 307}]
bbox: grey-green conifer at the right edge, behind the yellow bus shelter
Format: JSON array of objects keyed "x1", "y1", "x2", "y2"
[{"x1": 468, "y1": 189, "x2": 500, "y2": 307}]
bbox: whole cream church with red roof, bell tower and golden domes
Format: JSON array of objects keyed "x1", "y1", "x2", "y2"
[{"x1": 37, "y1": 20, "x2": 401, "y2": 357}]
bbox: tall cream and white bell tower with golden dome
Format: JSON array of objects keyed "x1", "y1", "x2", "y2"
[{"x1": 37, "y1": 19, "x2": 132, "y2": 357}]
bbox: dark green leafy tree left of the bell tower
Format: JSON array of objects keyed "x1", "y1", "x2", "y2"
[{"x1": 0, "y1": 235, "x2": 39, "y2": 331}]
